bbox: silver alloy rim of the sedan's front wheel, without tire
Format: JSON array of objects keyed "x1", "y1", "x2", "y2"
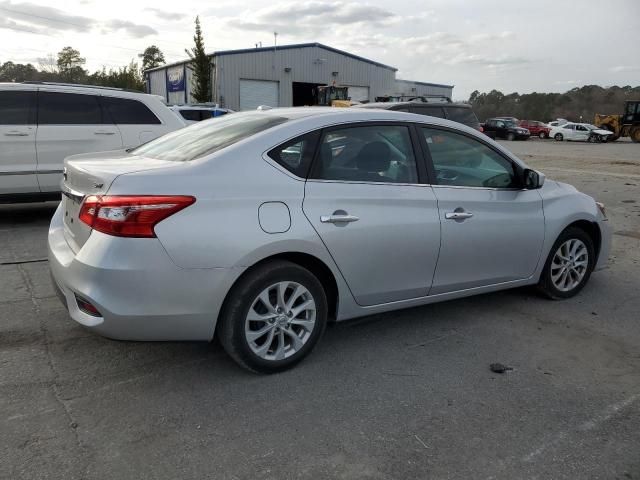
[{"x1": 551, "y1": 238, "x2": 589, "y2": 292}]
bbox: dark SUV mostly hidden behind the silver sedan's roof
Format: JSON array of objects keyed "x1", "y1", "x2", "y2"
[{"x1": 353, "y1": 97, "x2": 482, "y2": 131}]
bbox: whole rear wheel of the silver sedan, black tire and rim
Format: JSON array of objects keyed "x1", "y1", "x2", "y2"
[{"x1": 217, "y1": 260, "x2": 328, "y2": 373}]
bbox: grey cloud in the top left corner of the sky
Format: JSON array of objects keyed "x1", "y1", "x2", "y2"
[{"x1": 0, "y1": 0, "x2": 95, "y2": 32}]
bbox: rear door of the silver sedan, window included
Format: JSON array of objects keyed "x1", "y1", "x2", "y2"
[{"x1": 303, "y1": 124, "x2": 440, "y2": 305}]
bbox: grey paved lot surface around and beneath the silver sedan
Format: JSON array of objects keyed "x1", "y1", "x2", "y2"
[{"x1": 0, "y1": 139, "x2": 640, "y2": 480}]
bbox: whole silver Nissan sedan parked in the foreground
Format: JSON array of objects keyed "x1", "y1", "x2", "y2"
[{"x1": 49, "y1": 107, "x2": 611, "y2": 372}]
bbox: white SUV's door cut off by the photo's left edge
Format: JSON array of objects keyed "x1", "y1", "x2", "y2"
[{"x1": 0, "y1": 88, "x2": 39, "y2": 195}]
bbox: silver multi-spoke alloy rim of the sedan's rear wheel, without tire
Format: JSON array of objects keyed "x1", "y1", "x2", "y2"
[{"x1": 244, "y1": 281, "x2": 317, "y2": 360}]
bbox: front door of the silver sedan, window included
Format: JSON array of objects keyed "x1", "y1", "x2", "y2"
[{"x1": 420, "y1": 128, "x2": 544, "y2": 295}]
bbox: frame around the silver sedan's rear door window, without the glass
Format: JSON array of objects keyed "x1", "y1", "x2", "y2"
[{"x1": 306, "y1": 120, "x2": 429, "y2": 186}]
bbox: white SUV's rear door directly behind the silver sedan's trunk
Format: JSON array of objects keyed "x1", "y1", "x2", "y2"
[{"x1": 36, "y1": 89, "x2": 122, "y2": 192}]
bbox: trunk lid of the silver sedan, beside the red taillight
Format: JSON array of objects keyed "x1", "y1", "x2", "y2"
[{"x1": 61, "y1": 150, "x2": 179, "y2": 253}]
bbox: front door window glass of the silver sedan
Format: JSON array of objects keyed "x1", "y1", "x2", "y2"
[{"x1": 421, "y1": 128, "x2": 520, "y2": 188}]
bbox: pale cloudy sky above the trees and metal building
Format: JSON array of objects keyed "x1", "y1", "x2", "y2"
[{"x1": 0, "y1": 0, "x2": 640, "y2": 100}]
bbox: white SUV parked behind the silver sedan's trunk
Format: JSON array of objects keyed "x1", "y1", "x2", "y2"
[{"x1": 0, "y1": 82, "x2": 186, "y2": 203}]
